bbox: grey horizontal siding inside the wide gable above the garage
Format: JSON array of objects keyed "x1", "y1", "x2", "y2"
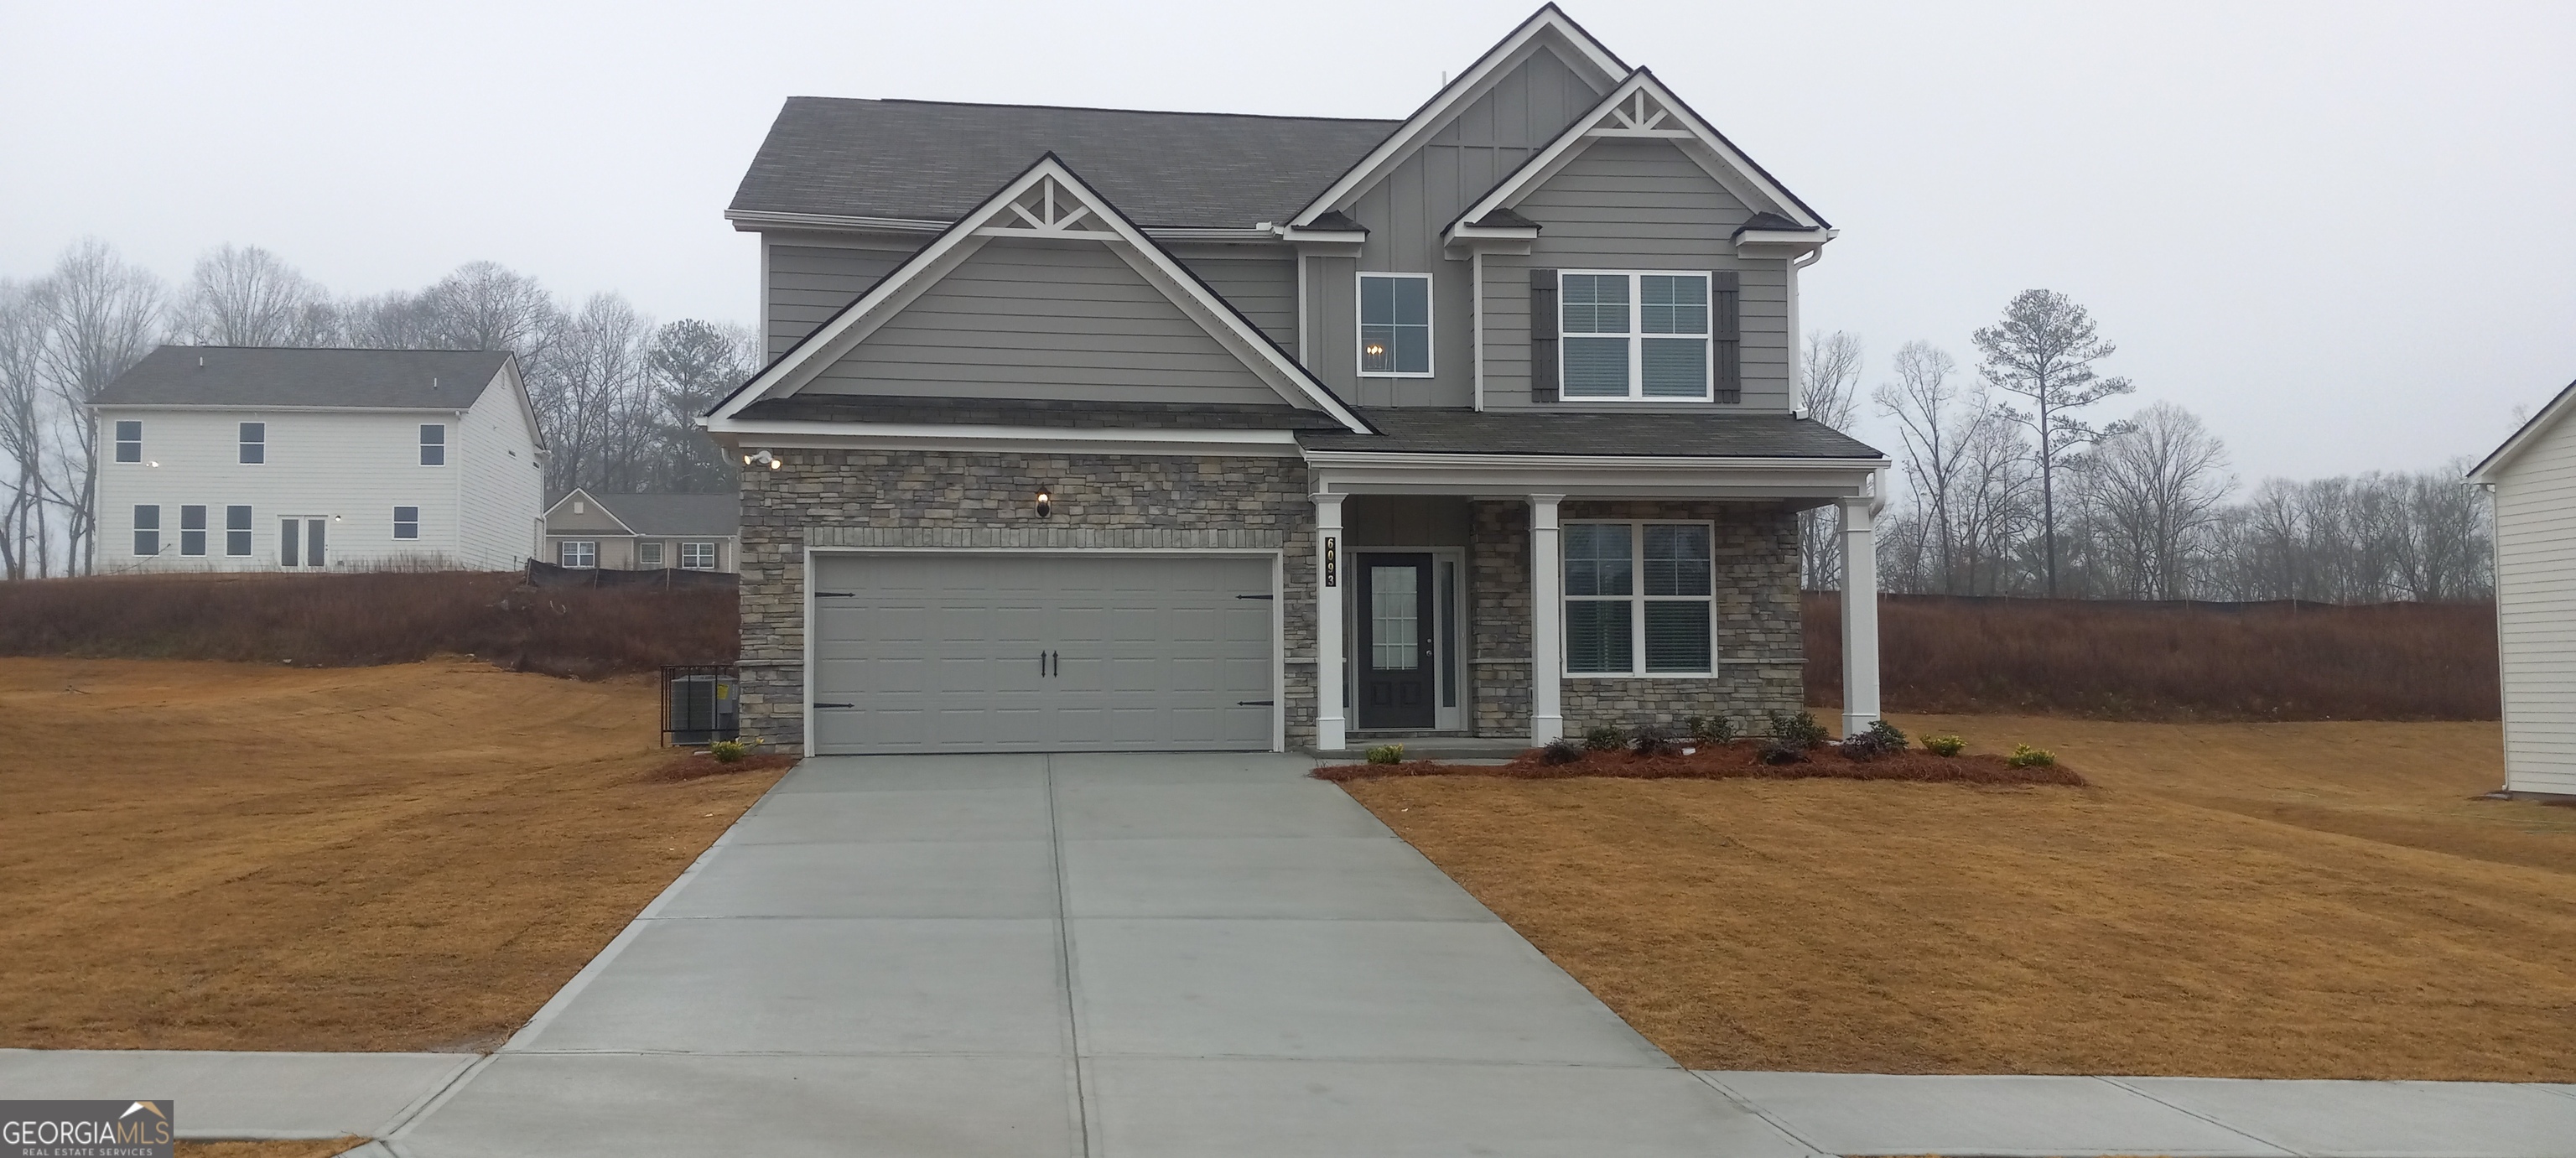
[{"x1": 803, "y1": 239, "x2": 1280, "y2": 404}]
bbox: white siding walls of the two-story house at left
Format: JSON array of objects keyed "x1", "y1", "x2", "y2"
[{"x1": 98, "y1": 383, "x2": 543, "y2": 571}]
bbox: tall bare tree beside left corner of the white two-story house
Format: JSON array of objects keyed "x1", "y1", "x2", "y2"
[{"x1": 36, "y1": 236, "x2": 168, "y2": 571}]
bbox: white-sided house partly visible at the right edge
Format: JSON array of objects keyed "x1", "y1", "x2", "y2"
[{"x1": 2468, "y1": 383, "x2": 2576, "y2": 795}]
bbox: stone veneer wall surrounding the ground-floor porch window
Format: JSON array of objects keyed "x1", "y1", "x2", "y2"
[{"x1": 1471, "y1": 501, "x2": 1805, "y2": 736}]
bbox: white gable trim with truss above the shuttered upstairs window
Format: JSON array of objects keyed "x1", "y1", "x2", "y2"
[{"x1": 1442, "y1": 70, "x2": 1836, "y2": 257}]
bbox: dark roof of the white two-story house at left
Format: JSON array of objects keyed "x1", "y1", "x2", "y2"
[{"x1": 93, "y1": 345, "x2": 510, "y2": 409}]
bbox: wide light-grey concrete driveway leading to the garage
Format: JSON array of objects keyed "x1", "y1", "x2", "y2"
[{"x1": 392, "y1": 756, "x2": 1811, "y2": 1158}]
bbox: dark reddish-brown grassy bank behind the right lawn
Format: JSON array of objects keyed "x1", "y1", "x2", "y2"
[{"x1": 1805, "y1": 592, "x2": 2496, "y2": 720}]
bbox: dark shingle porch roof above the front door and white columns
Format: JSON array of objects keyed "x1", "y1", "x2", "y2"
[{"x1": 1296, "y1": 407, "x2": 1881, "y2": 458}]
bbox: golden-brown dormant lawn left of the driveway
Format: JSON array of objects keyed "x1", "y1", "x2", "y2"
[{"x1": 0, "y1": 659, "x2": 778, "y2": 1050}]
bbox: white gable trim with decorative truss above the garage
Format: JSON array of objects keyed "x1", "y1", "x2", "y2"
[{"x1": 704, "y1": 152, "x2": 1370, "y2": 445}]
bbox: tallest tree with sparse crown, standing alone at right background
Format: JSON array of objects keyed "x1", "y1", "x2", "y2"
[{"x1": 1973, "y1": 288, "x2": 2133, "y2": 597}]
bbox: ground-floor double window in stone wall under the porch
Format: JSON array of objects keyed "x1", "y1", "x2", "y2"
[{"x1": 1564, "y1": 522, "x2": 1716, "y2": 674}]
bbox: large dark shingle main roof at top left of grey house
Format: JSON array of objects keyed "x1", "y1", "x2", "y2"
[{"x1": 731, "y1": 98, "x2": 1401, "y2": 226}]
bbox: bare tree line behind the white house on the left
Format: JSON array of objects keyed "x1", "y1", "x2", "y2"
[{"x1": 0, "y1": 239, "x2": 760, "y2": 579}]
